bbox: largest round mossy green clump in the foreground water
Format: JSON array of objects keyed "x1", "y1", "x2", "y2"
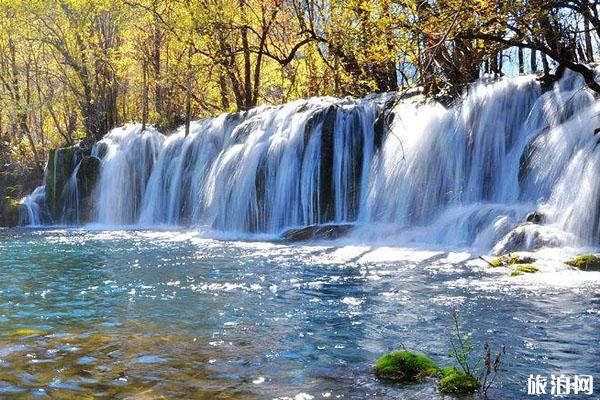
[{"x1": 374, "y1": 350, "x2": 439, "y2": 383}]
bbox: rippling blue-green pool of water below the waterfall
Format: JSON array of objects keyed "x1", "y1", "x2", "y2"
[{"x1": 0, "y1": 229, "x2": 600, "y2": 399}]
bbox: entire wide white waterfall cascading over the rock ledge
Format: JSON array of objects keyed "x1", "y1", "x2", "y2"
[{"x1": 21, "y1": 69, "x2": 600, "y2": 251}]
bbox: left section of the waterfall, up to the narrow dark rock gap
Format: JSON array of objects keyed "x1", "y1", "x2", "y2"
[{"x1": 96, "y1": 95, "x2": 390, "y2": 233}]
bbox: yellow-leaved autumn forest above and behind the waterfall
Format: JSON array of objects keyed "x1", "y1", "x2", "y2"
[{"x1": 0, "y1": 0, "x2": 600, "y2": 197}]
